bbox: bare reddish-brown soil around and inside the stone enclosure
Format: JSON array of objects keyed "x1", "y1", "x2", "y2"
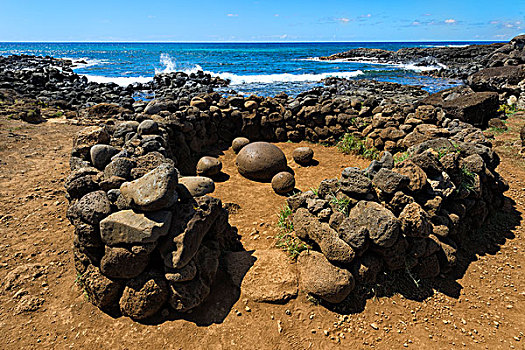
[{"x1": 0, "y1": 115, "x2": 525, "y2": 349}]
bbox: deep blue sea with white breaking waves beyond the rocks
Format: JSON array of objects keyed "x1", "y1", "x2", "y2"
[{"x1": 0, "y1": 42, "x2": 498, "y2": 96}]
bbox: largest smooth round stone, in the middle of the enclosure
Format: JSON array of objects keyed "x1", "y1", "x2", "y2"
[{"x1": 235, "y1": 142, "x2": 287, "y2": 181}]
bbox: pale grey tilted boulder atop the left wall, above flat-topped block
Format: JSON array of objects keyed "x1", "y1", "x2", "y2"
[{"x1": 120, "y1": 163, "x2": 178, "y2": 211}]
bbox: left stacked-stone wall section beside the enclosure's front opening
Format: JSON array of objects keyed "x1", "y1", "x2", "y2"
[{"x1": 65, "y1": 120, "x2": 238, "y2": 319}]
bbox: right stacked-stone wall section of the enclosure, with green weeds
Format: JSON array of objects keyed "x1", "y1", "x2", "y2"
[{"x1": 288, "y1": 133, "x2": 508, "y2": 303}]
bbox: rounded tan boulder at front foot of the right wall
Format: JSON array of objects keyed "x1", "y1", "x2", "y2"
[{"x1": 297, "y1": 250, "x2": 355, "y2": 303}]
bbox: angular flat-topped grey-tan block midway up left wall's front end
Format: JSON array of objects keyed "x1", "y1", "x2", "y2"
[{"x1": 100, "y1": 210, "x2": 172, "y2": 246}]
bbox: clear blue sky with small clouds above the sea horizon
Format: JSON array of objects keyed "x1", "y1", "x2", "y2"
[{"x1": 0, "y1": 0, "x2": 525, "y2": 41}]
